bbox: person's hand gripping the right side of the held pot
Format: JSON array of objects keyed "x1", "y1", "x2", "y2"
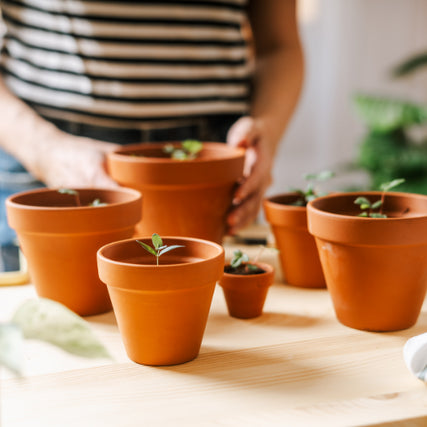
[{"x1": 227, "y1": 116, "x2": 274, "y2": 235}]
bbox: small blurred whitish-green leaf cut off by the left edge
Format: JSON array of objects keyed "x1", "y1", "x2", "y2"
[{"x1": 0, "y1": 323, "x2": 24, "y2": 375}]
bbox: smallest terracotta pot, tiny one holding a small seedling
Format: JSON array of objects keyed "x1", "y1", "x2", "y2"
[{"x1": 219, "y1": 263, "x2": 274, "y2": 319}]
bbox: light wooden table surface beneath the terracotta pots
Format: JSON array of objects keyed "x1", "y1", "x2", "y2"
[{"x1": 0, "y1": 236, "x2": 427, "y2": 427}]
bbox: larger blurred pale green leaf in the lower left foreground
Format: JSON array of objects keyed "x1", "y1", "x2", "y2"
[{"x1": 12, "y1": 298, "x2": 111, "y2": 358}]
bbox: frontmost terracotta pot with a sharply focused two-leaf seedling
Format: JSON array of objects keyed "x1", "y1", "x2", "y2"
[{"x1": 98, "y1": 237, "x2": 224, "y2": 365}]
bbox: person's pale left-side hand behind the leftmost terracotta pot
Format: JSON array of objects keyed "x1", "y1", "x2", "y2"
[{"x1": 30, "y1": 130, "x2": 118, "y2": 188}]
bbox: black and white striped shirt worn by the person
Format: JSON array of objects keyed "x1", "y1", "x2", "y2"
[{"x1": 0, "y1": 0, "x2": 252, "y2": 128}]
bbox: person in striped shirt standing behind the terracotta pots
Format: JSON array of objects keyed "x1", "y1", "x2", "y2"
[{"x1": 0, "y1": 0, "x2": 304, "y2": 270}]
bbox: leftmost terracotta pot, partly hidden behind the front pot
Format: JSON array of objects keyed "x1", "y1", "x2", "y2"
[{"x1": 6, "y1": 188, "x2": 141, "y2": 316}]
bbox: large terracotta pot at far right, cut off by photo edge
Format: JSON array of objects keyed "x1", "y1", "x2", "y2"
[{"x1": 308, "y1": 192, "x2": 427, "y2": 331}]
